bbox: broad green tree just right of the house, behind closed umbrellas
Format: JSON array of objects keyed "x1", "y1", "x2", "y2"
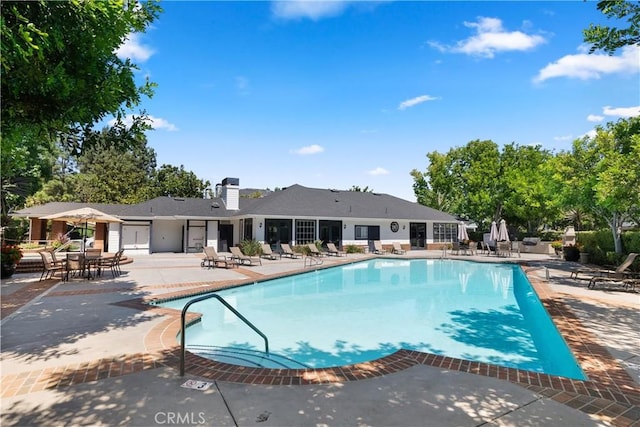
[{"x1": 411, "y1": 140, "x2": 560, "y2": 232}]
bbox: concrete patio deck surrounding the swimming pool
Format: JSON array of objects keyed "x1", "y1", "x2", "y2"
[{"x1": 0, "y1": 251, "x2": 640, "y2": 426}]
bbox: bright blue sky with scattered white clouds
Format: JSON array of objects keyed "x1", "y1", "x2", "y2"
[{"x1": 119, "y1": 1, "x2": 640, "y2": 201}]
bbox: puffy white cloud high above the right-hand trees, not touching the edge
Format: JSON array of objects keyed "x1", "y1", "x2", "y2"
[{"x1": 429, "y1": 16, "x2": 546, "y2": 58}]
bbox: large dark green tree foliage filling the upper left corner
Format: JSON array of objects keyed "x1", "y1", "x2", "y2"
[{"x1": 0, "y1": 0, "x2": 161, "y2": 225}]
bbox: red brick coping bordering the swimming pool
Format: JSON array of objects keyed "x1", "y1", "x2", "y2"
[{"x1": 118, "y1": 257, "x2": 640, "y2": 425}]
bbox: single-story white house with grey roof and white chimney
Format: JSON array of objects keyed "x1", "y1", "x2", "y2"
[{"x1": 13, "y1": 178, "x2": 459, "y2": 254}]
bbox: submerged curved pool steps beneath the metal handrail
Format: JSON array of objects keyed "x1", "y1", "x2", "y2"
[{"x1": 186, "y1": 344, "x2": 310, "y2": 369}]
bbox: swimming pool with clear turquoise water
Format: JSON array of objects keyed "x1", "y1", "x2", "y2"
[{"x1": 160, "y1": 259, "x2": 586, "y2": 379}]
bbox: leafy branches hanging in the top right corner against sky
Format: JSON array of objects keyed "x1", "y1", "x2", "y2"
[{"x1": 583, "y1": 0, "x2": 640, "y2": 55}]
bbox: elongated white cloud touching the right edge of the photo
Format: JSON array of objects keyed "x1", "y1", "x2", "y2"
[{"x1": 533, "y1": 46, "x2": 640, "y2": 83}]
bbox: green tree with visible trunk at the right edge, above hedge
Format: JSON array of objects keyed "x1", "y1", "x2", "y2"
[{"x1": 555, "y1": 117, "x2": 640, "y2": 253}]
